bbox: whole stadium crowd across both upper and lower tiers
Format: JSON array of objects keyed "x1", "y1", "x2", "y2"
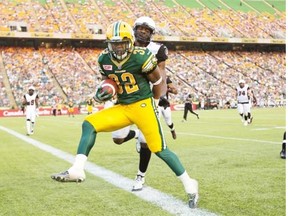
[{"x1": 0, "y1": 0, "x2": 286, "y2": 107}]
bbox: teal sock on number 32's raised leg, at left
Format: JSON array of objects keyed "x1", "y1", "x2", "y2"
[{"x1": 77, "y1": 121, "x2": 97, "y2": 156}]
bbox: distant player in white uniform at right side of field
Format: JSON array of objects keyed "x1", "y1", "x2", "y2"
[{"x1": 236, "y1": 79, "x2": 256, "y2": 126}]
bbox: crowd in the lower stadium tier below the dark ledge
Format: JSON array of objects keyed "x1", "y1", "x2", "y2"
[{"x1": 0, "y1": 47, "x2": 286, "y2": 107}]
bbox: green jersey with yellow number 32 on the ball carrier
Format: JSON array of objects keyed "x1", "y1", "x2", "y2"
[{"x1": 98, "y1": 47, "x2": 157, "y2": 104}]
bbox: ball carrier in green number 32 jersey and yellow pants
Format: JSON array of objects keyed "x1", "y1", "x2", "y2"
[{"x1": 51, "y1": 21, "x2": 198, "y2": 208}]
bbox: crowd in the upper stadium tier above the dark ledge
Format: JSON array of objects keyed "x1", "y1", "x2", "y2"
[{"x1": 0, "y1": 0, "x2": 286, "y2": 38}]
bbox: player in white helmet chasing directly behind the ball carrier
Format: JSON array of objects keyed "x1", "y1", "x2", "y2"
[{"x1": 112, "y1": 16, "x2": 177, "y2": 191}]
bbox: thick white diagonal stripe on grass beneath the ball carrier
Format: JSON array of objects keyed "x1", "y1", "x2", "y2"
[{"x1": 0, "y1": 126, "x2": 216, "y2": 216}]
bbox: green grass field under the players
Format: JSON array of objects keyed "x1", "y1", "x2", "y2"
[{"x1": 0, "y1": 108, "x2": 286, "y2": 216}]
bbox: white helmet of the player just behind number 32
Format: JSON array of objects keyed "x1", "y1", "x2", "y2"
[{"x1": 133, "y1": 16, "x2": 156, "y2": 43}]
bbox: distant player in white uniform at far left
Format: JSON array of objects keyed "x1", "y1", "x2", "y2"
[{"x1": 22, "y1": 86, "x2": 39, "y2": 136}]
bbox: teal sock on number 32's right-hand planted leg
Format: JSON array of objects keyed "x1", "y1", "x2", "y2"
[{"x1": 156, "y1": 148, "x2": 185, "y2": 176}]
